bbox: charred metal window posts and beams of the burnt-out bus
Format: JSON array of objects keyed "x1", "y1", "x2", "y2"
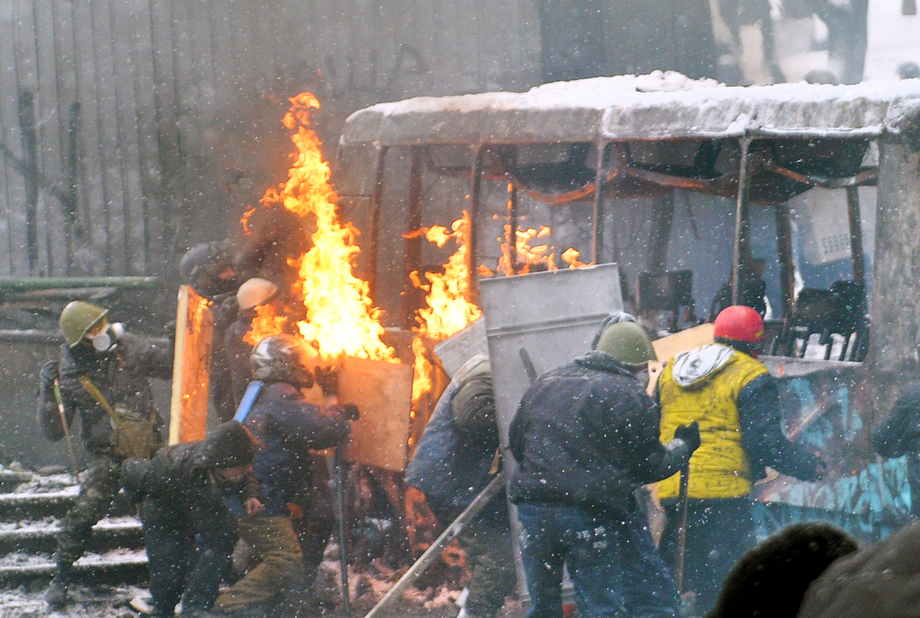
[{"x1": 368, "y1": 135, "x2": 878, "y2": 328}]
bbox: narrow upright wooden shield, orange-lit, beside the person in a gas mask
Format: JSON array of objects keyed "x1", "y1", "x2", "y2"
[{"x1": 169, "y1": 285, "x2": 214, "y2": 444}]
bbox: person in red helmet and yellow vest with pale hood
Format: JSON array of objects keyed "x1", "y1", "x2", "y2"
[{"x1": 658, "y1": 305, "x2": 825, "y2": 615}]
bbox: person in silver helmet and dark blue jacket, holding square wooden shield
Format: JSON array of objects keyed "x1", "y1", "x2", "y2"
[{"x1": 214, "y1": 335, "x2": 357, "y2": 616}]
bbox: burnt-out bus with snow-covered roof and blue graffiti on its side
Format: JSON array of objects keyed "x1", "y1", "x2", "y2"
[{"x1": 336, "y1": 73, "x2": 920, "y2": 539}]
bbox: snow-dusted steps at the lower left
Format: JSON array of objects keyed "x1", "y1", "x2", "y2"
[{"x1": 0, "y1": 471, "x2": 147, "y2": 590}]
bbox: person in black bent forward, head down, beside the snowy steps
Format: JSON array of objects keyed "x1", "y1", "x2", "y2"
[{"x1": 122, "y1": 421, "x2": 262, "y2": 618}]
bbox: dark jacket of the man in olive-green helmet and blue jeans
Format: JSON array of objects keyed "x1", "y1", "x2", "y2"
[{"x1": 509, "y1": 352, "x2": 690, "y2": 512}]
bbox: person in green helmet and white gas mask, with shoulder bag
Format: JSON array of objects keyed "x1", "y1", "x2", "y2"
[{"x1": 38, "y1": 301, "x2": 173, "y2": 608}]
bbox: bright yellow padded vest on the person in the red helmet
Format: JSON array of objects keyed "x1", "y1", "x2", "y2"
[{"x1": 658, "y1": 351, "x2": 767, "y2": 499}]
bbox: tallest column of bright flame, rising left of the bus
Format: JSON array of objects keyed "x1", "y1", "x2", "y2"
[{"x1": 250, "y1": 92, "x2": 398, "y2": 362}]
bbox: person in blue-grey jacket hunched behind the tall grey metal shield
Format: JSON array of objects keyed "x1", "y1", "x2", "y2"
[{"x1": 406, "y1": 354, "x2": 516, "y2": 618}]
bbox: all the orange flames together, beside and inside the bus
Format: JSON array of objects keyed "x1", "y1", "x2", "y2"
[{"x1": 242, "y1": 93, "x2": 585, "y2": 401}]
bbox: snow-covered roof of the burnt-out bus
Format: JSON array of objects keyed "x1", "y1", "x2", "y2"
[{"x1": 341, "y1": 72, "x2": 920, "y2": 148}]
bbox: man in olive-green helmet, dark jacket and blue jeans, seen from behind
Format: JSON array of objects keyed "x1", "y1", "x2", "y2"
[{"x1": 509, "y1": 322, "x2": 699, "y2": 618}]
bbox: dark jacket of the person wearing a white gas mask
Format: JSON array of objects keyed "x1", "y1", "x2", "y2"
[{"x1": 39, "y1": 333, "x2": 173, "y2": 454}]
